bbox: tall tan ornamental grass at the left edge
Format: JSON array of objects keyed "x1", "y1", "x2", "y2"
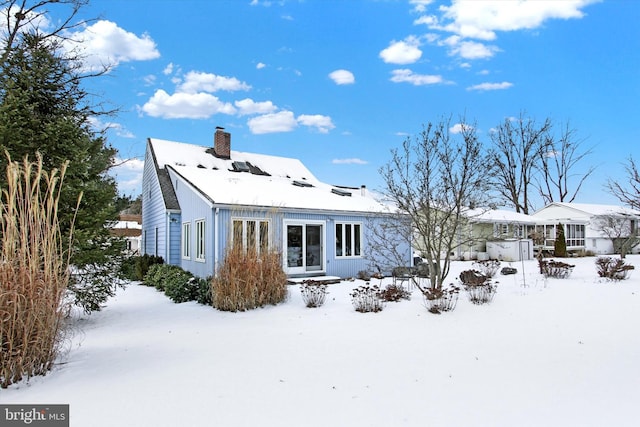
[{"x1": 0, "y1": 156, "x2": 73, "y2": 388}]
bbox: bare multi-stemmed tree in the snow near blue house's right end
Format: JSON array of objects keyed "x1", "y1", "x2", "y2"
[{"x1": 381, "y1": 118, "x2": 489, "y2": 293}]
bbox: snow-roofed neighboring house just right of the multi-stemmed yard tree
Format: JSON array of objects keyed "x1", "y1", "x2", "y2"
[{"x1": 455, "y1": 209, "x2": 535, "y2": 261}]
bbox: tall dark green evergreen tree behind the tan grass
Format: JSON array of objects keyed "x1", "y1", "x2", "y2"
[{"x1": 0, "y1": 32, "x2": 122, "y2": 312}]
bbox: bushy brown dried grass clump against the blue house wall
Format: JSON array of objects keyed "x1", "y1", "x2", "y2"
[{"x1": 212, "y1": 244, "x2": 287, "y2": 311}]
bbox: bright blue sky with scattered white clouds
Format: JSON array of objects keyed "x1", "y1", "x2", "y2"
[{"x1": 52, "y1": 0, "x2": 640, "y2": 207}]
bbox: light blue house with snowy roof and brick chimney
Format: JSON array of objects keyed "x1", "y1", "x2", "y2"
[{"x1": 142, "y1": 128, "x2": 411, "y2": 277}]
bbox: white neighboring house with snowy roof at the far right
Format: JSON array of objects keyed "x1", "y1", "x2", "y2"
[{"x1": 532, "y1": 202, "x2": 640, "y2": 255}]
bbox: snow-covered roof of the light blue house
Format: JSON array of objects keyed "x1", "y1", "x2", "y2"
[{"x1": 149, "y1": 138, "x2": 385, "y2": 212}]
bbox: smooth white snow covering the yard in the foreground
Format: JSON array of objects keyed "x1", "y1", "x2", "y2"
[{"x1": 5, "y1": 256, "x2": 640, "y2": 427}]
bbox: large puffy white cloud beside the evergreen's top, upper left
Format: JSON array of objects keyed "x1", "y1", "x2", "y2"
[{"x1": 66, "y1": 20, "x2": 160, "y2": 70}]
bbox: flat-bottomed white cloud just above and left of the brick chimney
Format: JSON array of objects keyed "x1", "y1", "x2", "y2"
[{"x1": 142, "y1": 89, "x2": 236, "y2": 119}]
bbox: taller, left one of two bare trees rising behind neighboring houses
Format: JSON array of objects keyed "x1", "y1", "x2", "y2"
[{"x1": 489, "y1": 113, "x2": 551, "y2": 214}]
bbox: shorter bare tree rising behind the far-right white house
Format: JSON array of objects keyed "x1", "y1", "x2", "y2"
[{"x1": 537, "y1": 123, "x2": 595, "y2": 204}]
